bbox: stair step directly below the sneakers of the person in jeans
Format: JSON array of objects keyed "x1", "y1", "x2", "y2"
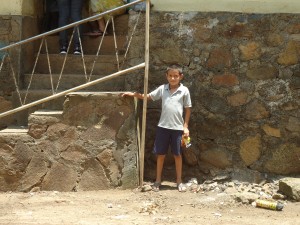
[{"x1": 30, "y1": 54, "x2": 123, "y2": 75}]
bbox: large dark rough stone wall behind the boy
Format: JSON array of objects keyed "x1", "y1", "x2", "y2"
[{"x1": 127, "y1": 12, "x2": 300, "y2": 179}]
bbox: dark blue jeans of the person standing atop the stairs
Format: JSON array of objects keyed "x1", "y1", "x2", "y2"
[{"x1": 57, "y1": 0, "x2": 83, "y2": 47}]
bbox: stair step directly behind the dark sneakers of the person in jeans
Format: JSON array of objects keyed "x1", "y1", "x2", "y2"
[{"x1": 35, "y1": 35, "x2": 127, "y2": 55}]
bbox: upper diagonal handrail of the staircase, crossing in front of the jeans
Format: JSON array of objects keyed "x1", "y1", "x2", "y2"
[{"x1": 0, "y1": 0, "x2": 145, "y2": 52}]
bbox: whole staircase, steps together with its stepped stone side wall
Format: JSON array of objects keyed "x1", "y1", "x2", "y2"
[{"x1": 0, "y1": 15, "x2": 139, "y2": 191}]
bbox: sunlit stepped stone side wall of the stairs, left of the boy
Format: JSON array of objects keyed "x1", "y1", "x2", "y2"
[{"x1": 0, "y1": 92, "x2": 139, "y2": 191}]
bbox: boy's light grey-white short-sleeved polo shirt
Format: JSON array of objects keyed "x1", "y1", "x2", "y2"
[{"x1": 149, "y1": 84, "x2": 192, "y2": 130}]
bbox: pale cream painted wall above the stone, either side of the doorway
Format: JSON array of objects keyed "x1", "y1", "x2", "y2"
[{"x1": 0, "y1": 0, "x2": 300, "y2": 16}]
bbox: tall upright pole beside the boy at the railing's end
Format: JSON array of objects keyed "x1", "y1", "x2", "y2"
[{"x1": 139, "y1": 0, "x2": 150, "y2": 186}]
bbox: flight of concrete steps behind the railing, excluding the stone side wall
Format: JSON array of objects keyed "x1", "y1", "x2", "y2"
[{"x1": 13, "y1": 14, "x2": 128, "y2": 126}]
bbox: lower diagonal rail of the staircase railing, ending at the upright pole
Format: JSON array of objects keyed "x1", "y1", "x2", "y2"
[{"x1": 0, "y1": 63, "x2": 145, "y2": 118}]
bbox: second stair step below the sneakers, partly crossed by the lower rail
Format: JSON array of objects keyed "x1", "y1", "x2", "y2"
[{"x1": 23, "y1": 74, "x2": 125, "y2": 91}]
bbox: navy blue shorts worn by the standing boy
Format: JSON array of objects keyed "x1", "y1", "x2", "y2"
[{"x1": 153, "y1": 127, "x2": 183, "y2": 155}]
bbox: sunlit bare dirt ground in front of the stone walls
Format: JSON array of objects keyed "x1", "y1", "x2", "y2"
[{"x1": 0, "y1": 183, "x2": 300, "y2": 225}]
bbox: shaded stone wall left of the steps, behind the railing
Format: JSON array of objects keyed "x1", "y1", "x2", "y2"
[{"x1": 0, "y1": 16, "x2": 39, "y2": 129}]
